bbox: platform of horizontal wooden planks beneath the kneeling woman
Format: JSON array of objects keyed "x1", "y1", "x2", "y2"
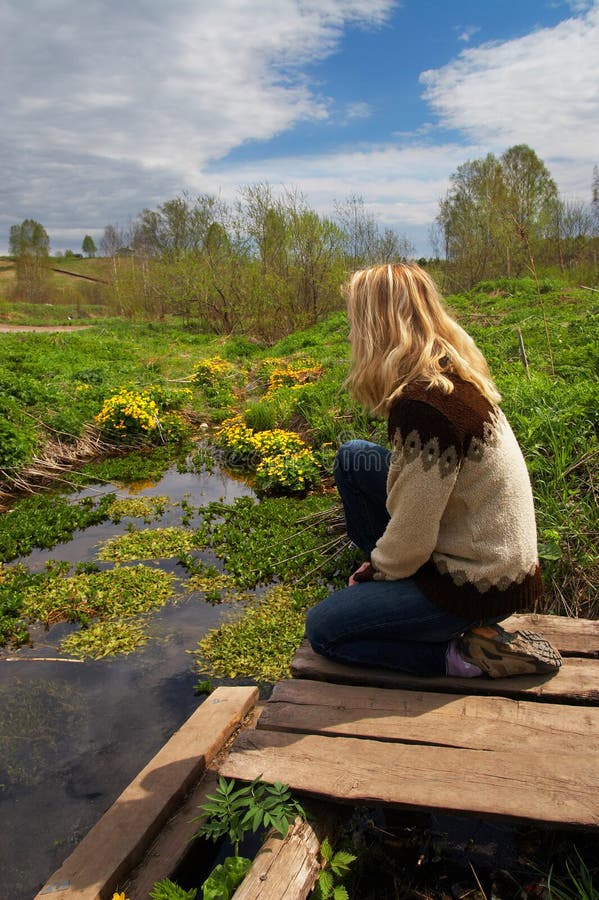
[{"x1": 220, "y1": 616, "x2": 599, "y2": 829}]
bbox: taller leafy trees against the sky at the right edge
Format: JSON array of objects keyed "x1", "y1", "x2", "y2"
[{"x1": 433, "y1": 144, "x2": 599, "y2": 289}]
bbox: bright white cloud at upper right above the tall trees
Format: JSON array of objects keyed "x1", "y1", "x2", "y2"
[{"x1": 421, "y1": 2, "x2": 599, "y2": 191}]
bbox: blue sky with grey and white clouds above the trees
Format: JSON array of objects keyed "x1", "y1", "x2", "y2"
[{"x1": 0, "y1": 0, "x2": 599, "y2": 256}]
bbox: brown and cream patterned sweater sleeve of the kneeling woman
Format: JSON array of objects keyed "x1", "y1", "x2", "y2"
[{"x1": 371, "y1": 398, "x2": 462, "y2": 581}]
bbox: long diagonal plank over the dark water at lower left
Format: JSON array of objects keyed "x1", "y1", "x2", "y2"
[{"x1": 37, "y1": 687, "x2": 258, "y2": 900}]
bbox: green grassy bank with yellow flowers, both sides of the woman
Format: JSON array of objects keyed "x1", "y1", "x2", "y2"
[{"x1": 0, "y1": 279, "x2": 599, "y2": 668}]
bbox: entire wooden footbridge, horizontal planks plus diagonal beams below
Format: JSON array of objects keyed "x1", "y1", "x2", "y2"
[{"x1": 38, "y1": 616, "x2": 599, "y2": 900}]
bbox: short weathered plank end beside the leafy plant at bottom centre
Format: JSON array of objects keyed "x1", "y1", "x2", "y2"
[{"x1": 233, "y1": 804, "x2": 342, "y2": 900}]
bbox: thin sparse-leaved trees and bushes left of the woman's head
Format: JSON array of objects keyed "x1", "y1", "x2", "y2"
[{"x1": 100, "y1": 183, "x2": 413, "y2": 339}]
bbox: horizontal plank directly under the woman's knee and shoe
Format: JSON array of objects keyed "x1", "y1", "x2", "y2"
[{"x1": 291, "y1": 641, "x2": 599, "y2": 706}]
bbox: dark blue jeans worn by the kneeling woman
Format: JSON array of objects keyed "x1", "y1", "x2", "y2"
[{"x1": 306, "y1": 440, "x2": 497, "y2": 675}]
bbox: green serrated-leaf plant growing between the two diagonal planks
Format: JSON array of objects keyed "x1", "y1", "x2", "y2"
[{"x1": 196, "y1": 776, "x2": 306, "y2": 900}]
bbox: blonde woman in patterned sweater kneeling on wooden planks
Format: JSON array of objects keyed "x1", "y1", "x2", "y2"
[{"x1": 307, "y1": 263, "x2": 561, "y2": 677}]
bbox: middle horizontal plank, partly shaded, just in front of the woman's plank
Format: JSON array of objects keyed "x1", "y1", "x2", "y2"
[{"x1": 258, "y1": 679, "x2": 599, "y2": 752}]
